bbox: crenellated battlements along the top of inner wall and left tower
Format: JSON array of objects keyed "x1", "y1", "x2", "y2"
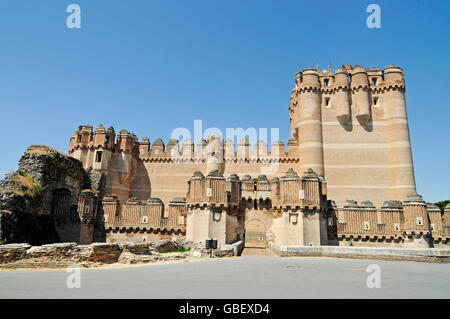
[{"x1": 69, "y1": 124, "x2": 298, "y2": 169}]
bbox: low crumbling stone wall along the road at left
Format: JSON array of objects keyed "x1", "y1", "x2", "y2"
[{"x1": 0, "y1": 241, "x2": 238, "y2": 268}]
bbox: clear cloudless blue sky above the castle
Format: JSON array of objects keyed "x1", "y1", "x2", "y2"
[{"x1": 0, "y1": 0, "x2": 450, "y2": 201}]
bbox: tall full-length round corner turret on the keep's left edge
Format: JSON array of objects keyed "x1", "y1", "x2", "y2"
[{"x1": 292, "y1": 68, "x2": 324, "y2": 175}]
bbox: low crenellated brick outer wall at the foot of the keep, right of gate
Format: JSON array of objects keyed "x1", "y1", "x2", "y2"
[{"x1": 332, "y1": 193, "x2": 450, "y2": 248}]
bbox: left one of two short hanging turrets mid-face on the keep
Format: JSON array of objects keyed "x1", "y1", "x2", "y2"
[{"x1": 334, "y1": 68, "x2": 351, "y2": 125}]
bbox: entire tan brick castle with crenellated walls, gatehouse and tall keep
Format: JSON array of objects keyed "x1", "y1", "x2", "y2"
[{"x1": 69, "y1": 65, "x2": 450, "y2": 247}]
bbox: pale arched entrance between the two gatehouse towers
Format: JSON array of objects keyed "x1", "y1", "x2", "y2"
[{"x1": 244, "y1": 211, "x2": 268, "y2": 248}]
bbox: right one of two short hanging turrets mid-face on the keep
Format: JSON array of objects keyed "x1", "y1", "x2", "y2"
[{"x1": 351, "y1": 66, "x2": 370, "y2": 126}]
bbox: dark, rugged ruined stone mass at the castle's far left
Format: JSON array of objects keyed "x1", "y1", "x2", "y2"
[{"x1": 0, "y1": 145, "x2": 101, "y2": 245}]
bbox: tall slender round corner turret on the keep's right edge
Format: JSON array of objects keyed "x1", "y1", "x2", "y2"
[{"x1": 381, "y1": 65, "x2": 416, "y2": 200}]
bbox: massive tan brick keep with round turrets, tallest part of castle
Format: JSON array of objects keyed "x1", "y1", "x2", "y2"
[{"x1": 289, "y1": 65, "x2": 416, "y2": 205}]
